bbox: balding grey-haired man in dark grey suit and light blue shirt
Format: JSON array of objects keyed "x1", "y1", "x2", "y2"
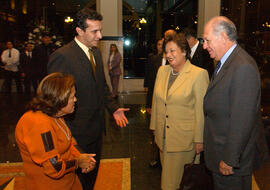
[{"x1": 203, "y1": 16, "x2": 261, "y2": 190}]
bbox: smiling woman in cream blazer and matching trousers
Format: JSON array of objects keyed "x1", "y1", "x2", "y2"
[{"x1": 150, "y1": 35, "x2": 209, "y2": 190}]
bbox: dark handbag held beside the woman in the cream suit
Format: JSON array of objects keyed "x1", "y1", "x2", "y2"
[{"x1": 180, "y1": 153, "x2": 214, "y2": 190}]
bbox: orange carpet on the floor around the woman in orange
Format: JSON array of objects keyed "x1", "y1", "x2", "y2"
[{"x1": 0, "y1": 158, "x2": 131, "y2": 190}]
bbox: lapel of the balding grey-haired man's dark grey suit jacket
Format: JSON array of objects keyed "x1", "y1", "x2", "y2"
[{"x1": 207, "y1": 45, "x2": 240, "y2": 92}]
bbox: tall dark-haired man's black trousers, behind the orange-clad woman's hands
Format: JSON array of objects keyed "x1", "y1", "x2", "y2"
[{"x1": 76, "y1": 137, "x2": 102, "y2": 190}]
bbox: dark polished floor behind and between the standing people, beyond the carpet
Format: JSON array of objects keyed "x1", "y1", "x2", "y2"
[{"x1": 0, "y1": 92, "x2": 270, "y2": 190}]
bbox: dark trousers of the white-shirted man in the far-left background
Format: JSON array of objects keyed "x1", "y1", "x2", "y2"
[{"x1": 4, "y1": 71, "x2": 22, "y2": 93}]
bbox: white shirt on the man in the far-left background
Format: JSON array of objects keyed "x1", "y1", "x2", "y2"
[{"x1": 1, "y1": 48, "x2": 20, "y2": 72}]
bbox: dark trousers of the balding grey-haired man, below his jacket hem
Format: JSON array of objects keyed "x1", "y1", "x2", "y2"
[{"x1": 213, "y1": 173, "x2": 252, "y2": 190}]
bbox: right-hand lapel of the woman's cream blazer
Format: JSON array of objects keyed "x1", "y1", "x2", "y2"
[{"x1": 167, "y1": 60, "x2": 191, "y2": 97}]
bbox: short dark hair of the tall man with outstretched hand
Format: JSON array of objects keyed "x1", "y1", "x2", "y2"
[{"x1": 74, "y1": 7, "x2": 103, "y2": 31}]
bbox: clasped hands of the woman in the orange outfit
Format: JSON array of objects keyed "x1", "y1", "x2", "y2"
[{"x1": 78, "y1": 153, "x2": 96, "y2": 173}]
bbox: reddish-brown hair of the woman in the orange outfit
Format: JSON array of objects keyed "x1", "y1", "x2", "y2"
[{"x1": 27, "y1": 72, "x2": 75, "y2": 117}]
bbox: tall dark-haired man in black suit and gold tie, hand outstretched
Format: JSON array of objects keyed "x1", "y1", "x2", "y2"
[{"x1": 48, "y1": 8, "x2": 128, "y2": 190}]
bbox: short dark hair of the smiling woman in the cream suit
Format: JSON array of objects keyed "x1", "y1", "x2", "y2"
[{"x1": 165, "y1": 33, "x2": 191, "y2": 59}]
